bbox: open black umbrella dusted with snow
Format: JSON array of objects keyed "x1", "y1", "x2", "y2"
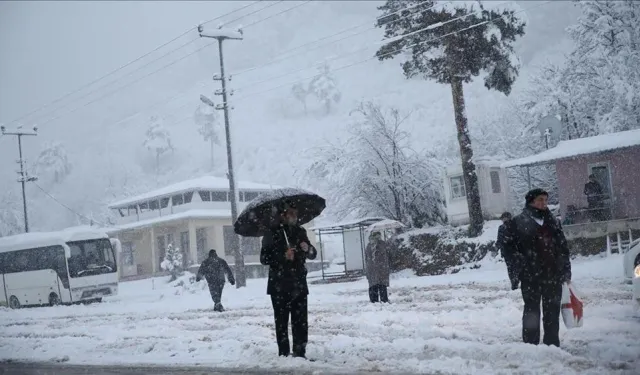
[{"x1": 233, "y1": 188, "x2": 325, "y2": 237}]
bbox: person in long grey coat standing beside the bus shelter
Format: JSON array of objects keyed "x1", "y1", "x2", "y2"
[{"x1": 364, "y1": 232, "x2": 391, "y2": 303}]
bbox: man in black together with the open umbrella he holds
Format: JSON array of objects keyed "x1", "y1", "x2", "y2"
[{"x1": 234, "y1": 189, "x2": 325, "y2": 359}]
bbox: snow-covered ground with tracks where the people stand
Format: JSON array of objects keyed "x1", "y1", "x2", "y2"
[{"x1": 0, "y1": 256, "x2": 640, "y2": 375}]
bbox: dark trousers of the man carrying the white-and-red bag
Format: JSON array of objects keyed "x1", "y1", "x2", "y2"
[{"x1": 521, "y1": 279, "x2": 562, "y2": 346}]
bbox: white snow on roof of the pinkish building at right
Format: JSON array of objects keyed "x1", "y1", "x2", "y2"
[{"x1": 502, "y1": 129, "x2": 640, "y2": 168}]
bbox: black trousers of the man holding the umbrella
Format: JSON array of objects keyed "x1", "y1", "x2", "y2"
[{"x1": 271, "y1": 292, "x2": 309, "y2": 357}]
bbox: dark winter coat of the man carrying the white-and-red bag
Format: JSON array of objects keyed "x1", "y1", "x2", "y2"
[{"x1": 506, "y1": 207, "x2": 571, "y2": 281}]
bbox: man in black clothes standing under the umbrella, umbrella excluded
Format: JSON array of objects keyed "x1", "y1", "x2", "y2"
[{"x1": 260, "y1": 202, "x2": 317, "y2": 358}]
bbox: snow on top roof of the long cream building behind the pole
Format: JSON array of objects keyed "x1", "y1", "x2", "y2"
[{"x1": 109, "y1": 176, "x2": 282, "y2": 208}]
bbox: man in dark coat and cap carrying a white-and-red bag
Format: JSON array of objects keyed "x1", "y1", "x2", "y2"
[{"x1": 508, "y1": 189, "x2": 571, "y2": 346}]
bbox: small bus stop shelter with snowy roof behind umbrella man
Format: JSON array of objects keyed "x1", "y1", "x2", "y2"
[{"x1": 311, "y1": 217, "x2": 387, "y2": 279}]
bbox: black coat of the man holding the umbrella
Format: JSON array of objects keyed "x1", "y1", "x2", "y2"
[{"x1": 260, "y1": 225, "x2": 318, "y2": 295}]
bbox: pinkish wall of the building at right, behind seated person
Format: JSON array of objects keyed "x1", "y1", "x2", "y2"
[{"x1": 556, "y1": 146, "x2": 640, "y2": 219}]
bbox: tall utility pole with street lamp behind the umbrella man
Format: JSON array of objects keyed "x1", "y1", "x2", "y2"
[{"x1": 198, "y1": 25, "x2": 247, "y2": 288}]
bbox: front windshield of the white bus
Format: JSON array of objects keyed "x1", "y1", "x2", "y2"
[{"x1": 67, "y1": 238, "x2": 117, "y2": 278}]
